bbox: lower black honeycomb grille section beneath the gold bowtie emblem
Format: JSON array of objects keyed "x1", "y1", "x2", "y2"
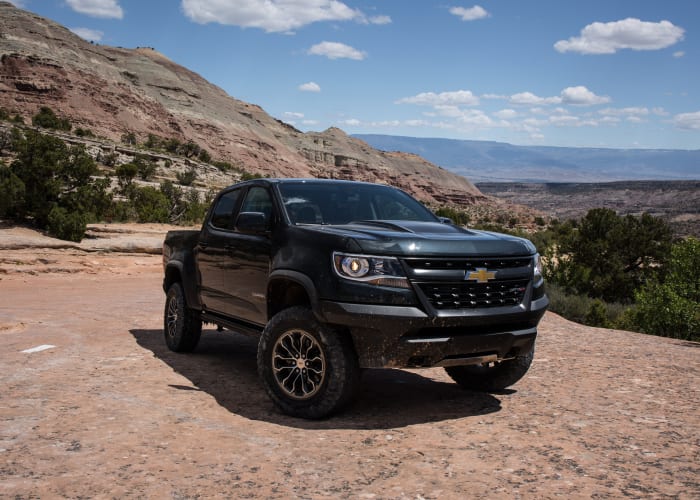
[{"x1": 418, "y1": 279, "x2": 529, "y2": 309}]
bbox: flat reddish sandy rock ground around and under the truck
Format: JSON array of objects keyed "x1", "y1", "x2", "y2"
[{"x1": 0, "y1": 226, "x2": 700, "y2": 499}]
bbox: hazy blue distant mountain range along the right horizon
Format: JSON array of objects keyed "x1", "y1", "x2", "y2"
[{"x1": 353, "y1": 134, "x2": 700, "y2": 182}]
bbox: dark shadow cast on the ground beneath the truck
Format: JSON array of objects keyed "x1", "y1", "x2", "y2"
[{"x1": 130, "y1": 330, "x2": 504, "y2": 429}]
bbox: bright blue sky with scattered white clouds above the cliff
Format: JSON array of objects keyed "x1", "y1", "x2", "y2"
[{"x1": 12, "y1": 0, "x2": 700, "y2": 149}]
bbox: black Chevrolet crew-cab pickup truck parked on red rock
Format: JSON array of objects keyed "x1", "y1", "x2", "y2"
[{"x1": 163, "y1": 179, "x2": 549, "y2": 418}]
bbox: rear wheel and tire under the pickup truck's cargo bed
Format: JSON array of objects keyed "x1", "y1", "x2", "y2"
[{"x1": 163, "y1": 282, "x2": 202, "y2": 352}]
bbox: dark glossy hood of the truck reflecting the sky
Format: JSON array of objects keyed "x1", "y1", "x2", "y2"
[{"x1": 300, "y1": 220, "x2": 536, "y2": 257}]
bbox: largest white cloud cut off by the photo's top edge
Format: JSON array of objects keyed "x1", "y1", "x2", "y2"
[{"x1": 182, "y1": 0, "x2": 365, "y2": 33}]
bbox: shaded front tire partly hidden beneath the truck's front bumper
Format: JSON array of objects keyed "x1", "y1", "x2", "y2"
[{"x1": 445, "y1": 346, "x2": 535, "y2": 392}]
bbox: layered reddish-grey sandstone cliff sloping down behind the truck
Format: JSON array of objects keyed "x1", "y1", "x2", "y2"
[{"x1": 0, "y1": 2, "x2": 486, "y2": 206}]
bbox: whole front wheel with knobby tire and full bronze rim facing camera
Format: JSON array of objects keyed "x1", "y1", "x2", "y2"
[{"x1": 257, "y1": 307, "x2": 360, "y2": 419}]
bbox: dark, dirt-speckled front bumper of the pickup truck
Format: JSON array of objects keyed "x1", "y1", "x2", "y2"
[{"x1": 317, "y1": 295, "x2": 549, "y2": 368}]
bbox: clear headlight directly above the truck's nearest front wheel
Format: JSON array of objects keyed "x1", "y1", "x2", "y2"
[{"x1": 333, "y1": 252, "x2": 411, "y2": 288}]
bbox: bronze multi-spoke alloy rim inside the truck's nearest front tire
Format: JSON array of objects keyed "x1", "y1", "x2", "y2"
[{"x1": 272, "y1": 330, "x2": 326, "y2": 400}]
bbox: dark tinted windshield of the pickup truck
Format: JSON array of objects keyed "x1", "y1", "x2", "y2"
[{"x1": 279, "y1": 181, "x2": 438, "y2": 224}]
